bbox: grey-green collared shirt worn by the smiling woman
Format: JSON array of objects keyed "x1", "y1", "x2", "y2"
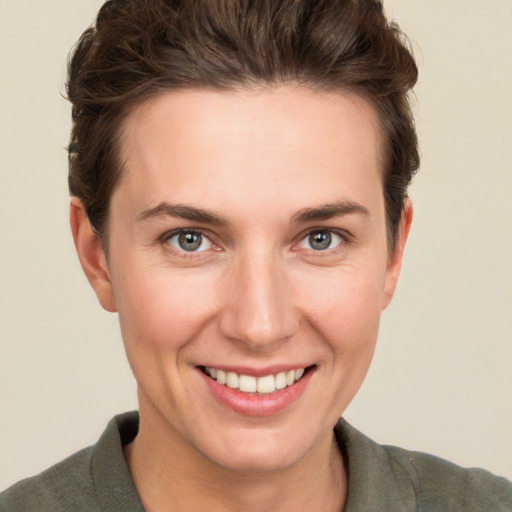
[{"x1": 0, "y1": 412, "x2": 512, "y2": 512}]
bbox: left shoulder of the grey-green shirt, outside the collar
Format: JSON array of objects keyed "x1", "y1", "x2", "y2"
[{"x1": 0, "y1": 447, "x2": 100, "y2": 512}]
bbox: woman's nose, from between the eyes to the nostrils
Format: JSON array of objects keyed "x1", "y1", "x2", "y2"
[{"x1": 219, "y1": 249, "x2": 299, "y2": 351}]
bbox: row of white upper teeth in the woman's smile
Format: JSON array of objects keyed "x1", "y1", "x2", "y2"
[{"x1": 205, "y1": 367, "x2": 304, "y2": 393}]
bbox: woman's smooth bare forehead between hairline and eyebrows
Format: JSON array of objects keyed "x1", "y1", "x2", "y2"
[{"x1": 114, "y1": 86, "x2": 382, "y2": 222}]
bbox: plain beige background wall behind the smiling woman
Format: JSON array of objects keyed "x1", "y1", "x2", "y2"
[{"x1": 0, "y1": 0, "x2": 512, "y2": 488}]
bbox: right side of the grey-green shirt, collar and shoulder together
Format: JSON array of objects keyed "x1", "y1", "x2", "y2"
[{"x1": 335, "y1": 420, "x2": 512, "y2": 512}]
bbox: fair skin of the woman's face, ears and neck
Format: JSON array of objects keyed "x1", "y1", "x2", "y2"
[{"x1": 71, "y1": 86, "x2": 412, "y2": 512}]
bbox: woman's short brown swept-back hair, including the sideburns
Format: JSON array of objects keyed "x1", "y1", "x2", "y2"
[{"x1": 67, "y1": 0, "x2": 419, "y2": 247}]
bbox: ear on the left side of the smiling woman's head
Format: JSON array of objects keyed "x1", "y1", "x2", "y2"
[{"x1": 69, "y1": 197, "x2": 117, "y2": 313}]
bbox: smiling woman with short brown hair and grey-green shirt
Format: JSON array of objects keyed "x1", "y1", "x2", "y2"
[{"x1": 0, "y1": 0, "x2": 512, "y2": 512}]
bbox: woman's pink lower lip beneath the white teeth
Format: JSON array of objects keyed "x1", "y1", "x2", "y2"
[{"x1": 198, "y1": 368, "x2": 314, "y2": 416}]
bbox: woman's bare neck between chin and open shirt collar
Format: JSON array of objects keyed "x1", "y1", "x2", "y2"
[{"x1": 125, "y1": 400, "x2": 347, "y2": 512}]
